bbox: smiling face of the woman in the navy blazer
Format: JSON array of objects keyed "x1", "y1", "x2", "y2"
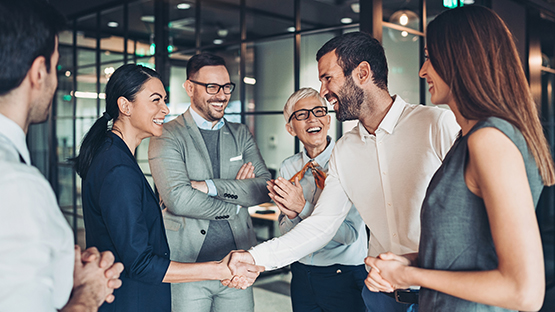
[{"x1": 129, "y1": 78, "x2": 170, "y2": 139}]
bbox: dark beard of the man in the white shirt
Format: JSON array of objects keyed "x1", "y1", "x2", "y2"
[{"x1": 335, "y1": 76, "x2": 364, "y2": 121}]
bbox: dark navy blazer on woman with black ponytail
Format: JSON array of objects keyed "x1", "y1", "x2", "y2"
[{"x1": 82, "y1": 132, "x2": 171, "y2": 312}]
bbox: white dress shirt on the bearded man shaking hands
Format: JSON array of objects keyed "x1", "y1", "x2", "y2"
[{"x1": 250, "y1": 96, "x2": 459, "y2": 269}]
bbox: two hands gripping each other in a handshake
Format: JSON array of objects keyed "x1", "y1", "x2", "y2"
[{"x1": 219, "y1": 250, "x2": 265, "y2": 289}]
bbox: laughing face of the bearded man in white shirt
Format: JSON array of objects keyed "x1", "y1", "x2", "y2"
[{"x1": 318, "y1": 51, "x2": 364, "y2": 121}]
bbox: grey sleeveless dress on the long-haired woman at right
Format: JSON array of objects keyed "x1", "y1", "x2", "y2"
[{"x1": 418, "y1": 117, "x2": 543, "y2": 312}]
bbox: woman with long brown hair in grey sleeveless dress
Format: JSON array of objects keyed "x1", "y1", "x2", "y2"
[{"x1": 366, "y1": 6, "x2": 555, "y2": 311}]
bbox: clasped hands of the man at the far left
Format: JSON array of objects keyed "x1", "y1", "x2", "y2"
[{"x1": 62, "y1": 246, "x2": 123, "y2": 311}]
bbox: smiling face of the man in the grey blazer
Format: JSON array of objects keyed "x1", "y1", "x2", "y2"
[{"x1": 185, "y1": 65, "x2": 231, "y2": 124}]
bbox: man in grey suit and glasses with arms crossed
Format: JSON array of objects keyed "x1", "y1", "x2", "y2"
[{"x1": 148, "y1": 53, "x2": 271, "y2": 312}]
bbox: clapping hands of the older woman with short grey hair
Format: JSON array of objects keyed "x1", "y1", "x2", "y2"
[{"x1": 266, "y1": 177, "x2": 306, "y2": 219}]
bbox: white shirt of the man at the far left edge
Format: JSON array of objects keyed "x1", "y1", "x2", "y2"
[{"x1": 0, "y1": 114, "x2": 74, "y2": 312}]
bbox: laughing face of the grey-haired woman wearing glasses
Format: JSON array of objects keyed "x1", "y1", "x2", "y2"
[{"x1": 285, "y1": 97, "x2": 331, "y2": 157}]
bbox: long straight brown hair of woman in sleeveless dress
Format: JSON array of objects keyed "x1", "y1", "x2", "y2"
[{"x1": 426, "y1": 6, "x2": 555, "y2": 185}]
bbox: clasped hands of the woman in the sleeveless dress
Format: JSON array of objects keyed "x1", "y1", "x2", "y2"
[{"x1": 364, "y1": 252, "x2": 418, "y2": 292}]
